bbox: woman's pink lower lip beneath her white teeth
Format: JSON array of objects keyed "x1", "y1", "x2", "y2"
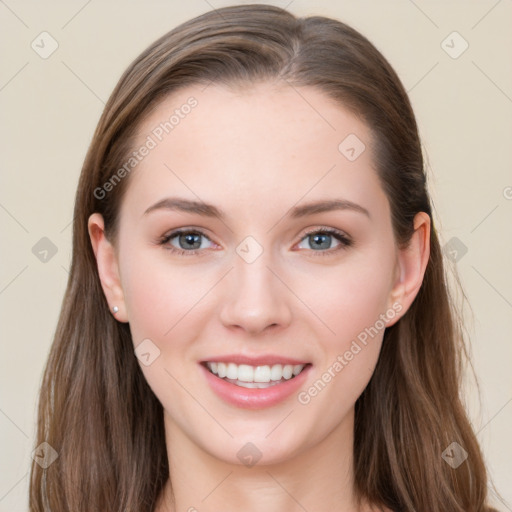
[{"x1": 199, "y1": 364, "x2": 311, "y2": 409}]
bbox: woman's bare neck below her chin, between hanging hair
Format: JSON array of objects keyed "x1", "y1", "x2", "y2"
[{"x1": 156, "y1": 410, "x2": 372, "y2": 512}]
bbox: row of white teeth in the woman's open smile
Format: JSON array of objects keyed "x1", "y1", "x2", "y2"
[{"x1": 206, "y1": 362, "x2": 306, "y2": 387}]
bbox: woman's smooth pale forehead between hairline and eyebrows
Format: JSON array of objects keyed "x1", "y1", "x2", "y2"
[{"x1": 119, "y1": 82, "x2": 382, "y2": 221}]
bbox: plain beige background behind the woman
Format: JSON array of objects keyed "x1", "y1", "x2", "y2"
[{"x1": 0, "y1": 0, "x2": 512, "y2": 512}]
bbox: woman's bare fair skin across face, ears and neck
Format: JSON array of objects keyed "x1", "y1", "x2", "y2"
[{"x1": 89, "y1": 83, "x2": 430, "y2": 512}]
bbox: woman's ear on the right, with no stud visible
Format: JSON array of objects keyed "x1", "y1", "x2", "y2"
[{"x1": 386, "y1": 212, "x2": 431, "y2": 327}]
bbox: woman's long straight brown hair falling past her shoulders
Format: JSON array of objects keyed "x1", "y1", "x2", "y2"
[{"x1": 30, "y1": 5, "x2": 502, "y2": 512}]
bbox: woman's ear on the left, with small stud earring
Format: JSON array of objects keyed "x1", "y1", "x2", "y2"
[{"x1": 87, "y1": 213, "x2": 128, "y2": 322}]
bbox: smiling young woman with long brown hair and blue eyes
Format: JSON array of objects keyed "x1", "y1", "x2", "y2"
[{"x1": 30, "y1": 5, "x2": 500, "y2": 512}]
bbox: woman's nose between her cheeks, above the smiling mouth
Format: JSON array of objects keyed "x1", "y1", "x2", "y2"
[{"x1": 220, "y1": 248, "x2": 293, "y2": 335}]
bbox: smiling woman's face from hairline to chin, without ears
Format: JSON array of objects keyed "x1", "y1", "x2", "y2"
[{"x1": 95, "y1": 84, "x2": 412, "y2": 464}]
